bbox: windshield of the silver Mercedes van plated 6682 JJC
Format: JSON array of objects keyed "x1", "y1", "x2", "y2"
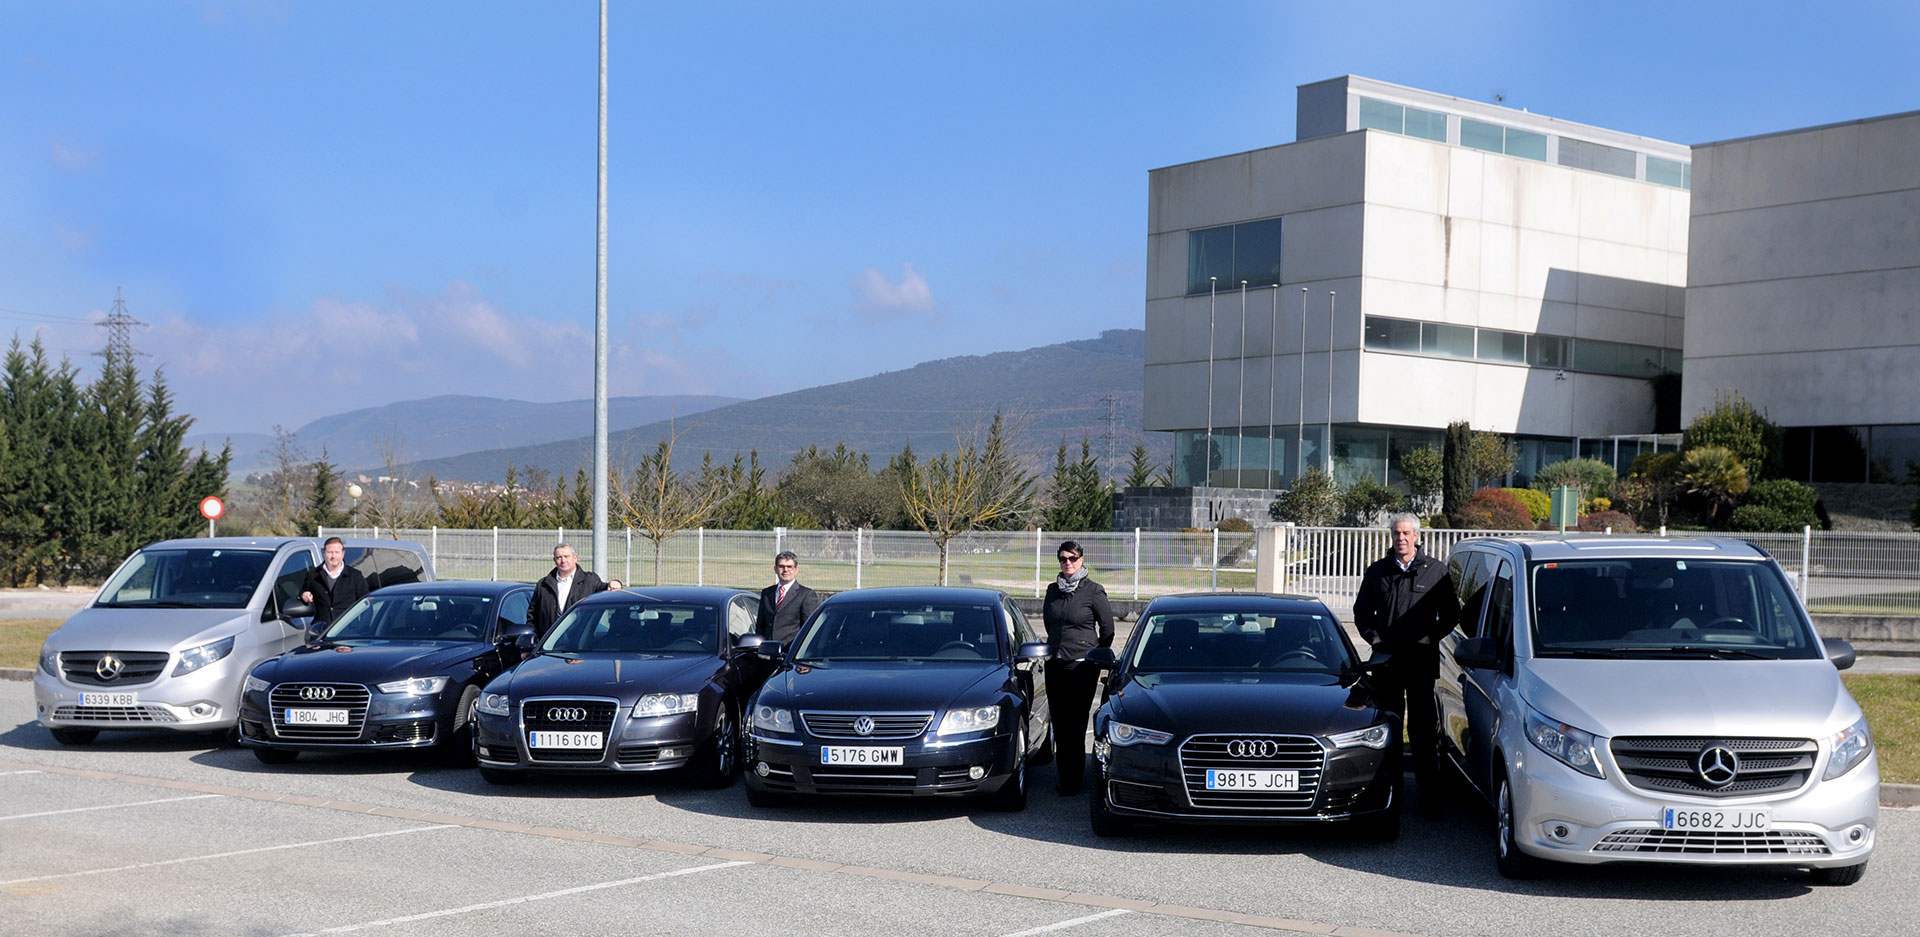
[{"x1": 1532, "y1": 559, "x2": 1822, "y2": 661}]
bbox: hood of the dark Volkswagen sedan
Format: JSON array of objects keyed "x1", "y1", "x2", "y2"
[{"x1": 762, "y1": 661, "x2": 1006, "y2": 712}]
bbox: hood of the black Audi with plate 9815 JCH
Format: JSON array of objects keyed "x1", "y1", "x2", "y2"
[{"x1": 1108, "y1": 672, "x2": 1380, "y2": 735}]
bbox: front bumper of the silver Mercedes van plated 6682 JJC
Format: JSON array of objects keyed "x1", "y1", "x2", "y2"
[{"x1": 1507, "y1": 741, "x2": 1880, "y2": 866}]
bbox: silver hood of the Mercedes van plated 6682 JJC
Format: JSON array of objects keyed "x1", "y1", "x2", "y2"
[{"x1": 1519, "y1": 659, "x2": 1860, "y2": 739}]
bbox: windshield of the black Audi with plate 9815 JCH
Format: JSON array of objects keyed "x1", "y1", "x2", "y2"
[{"x1": 1131, "y1": 611, "x2": 1357, "y2": 674}]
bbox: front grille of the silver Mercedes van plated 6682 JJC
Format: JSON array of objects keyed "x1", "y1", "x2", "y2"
[{"x1": 1607, "y1": 735, "x2": 1820, "y2": 797}]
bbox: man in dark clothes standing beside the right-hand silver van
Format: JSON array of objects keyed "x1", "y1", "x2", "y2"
[{"x1": 1354, "y1": 515, "x2": 1459, "y2": 820}]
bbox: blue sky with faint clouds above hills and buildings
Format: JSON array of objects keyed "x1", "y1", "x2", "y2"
[{"x1": 0, "y1": 0, "x2": 1920, "y2": 432}]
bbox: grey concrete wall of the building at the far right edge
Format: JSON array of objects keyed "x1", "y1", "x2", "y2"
[{"x1": 1680, "y1": 113, "x2": 1920, "y2": 426}]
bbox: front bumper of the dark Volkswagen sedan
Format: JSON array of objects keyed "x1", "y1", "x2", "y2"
[{"x1": 745, "y1": 732, "x2": 1020, "y2": 797}]
